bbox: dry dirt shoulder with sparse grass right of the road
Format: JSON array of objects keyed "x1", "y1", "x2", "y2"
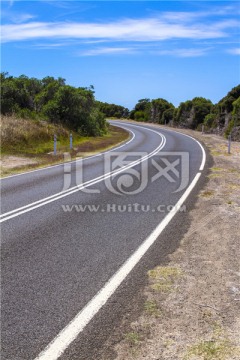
[{"x1": 111, "y1": 130, "x2": 240, "y2": 360}]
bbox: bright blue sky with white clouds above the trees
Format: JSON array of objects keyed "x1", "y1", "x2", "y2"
[{"x1": 1, "y1": 0, "x2": 240, "y2": 109}]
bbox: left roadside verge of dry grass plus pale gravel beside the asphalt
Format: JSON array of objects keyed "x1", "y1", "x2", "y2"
[{"x1": 1, "y1": 117, "x2": 129, "y2": 176}]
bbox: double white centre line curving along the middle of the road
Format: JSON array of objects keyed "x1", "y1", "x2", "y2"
[{"x1": 0, "y1": 129, "x2": 166, "y2": 223}]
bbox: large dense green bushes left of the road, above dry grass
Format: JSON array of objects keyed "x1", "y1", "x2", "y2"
[{"x1": 1, "y1": 73, "x2": 107, "y2": 135}]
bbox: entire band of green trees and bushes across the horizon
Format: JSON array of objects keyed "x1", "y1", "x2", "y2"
[{"x1": 1, "y1": 73, "x2": 240, "y2": 145}]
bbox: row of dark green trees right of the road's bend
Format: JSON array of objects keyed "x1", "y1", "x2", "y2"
[{"x1": 129, "y1": 85, "x2": 240, "y2": 141}]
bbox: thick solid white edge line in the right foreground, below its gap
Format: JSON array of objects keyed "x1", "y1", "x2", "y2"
[{"x1": 35, "y1": 168, "x2": 205, "y2": 360}]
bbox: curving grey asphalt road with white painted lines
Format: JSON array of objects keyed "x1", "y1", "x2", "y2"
[{"x1": 1, "y1": 122, "x2": 205, "y2": 360}]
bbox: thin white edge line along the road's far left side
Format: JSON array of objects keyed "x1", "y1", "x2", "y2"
[{"x1": 0, "y1": 124, "x2": 135, "y2": 181}]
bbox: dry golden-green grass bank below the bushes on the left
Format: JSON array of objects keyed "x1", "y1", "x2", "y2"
[{"x1": 1, "y1": 116, "x2": 129, "y2": 156}]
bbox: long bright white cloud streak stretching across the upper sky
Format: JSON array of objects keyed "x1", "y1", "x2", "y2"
[{"x1": 2, "y1": 18, "x2": 239, "y2": 42}]
